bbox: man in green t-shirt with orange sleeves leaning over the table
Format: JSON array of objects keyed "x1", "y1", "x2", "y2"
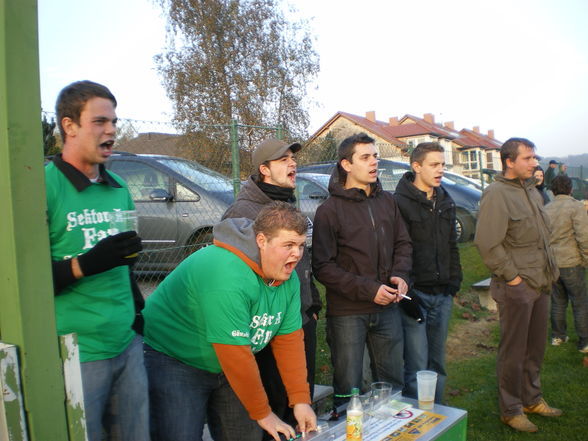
[{"x1": 143, "y1": 202, "x2": 316, "y2": 441}]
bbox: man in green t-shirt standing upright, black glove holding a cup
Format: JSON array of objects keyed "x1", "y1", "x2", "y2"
[{"x1": 45, "y1": 81, "x2": 149, "y2": 441}]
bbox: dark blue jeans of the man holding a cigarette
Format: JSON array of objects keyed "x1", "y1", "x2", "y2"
[{"x1": 327, "y1": 305, "x2": 403, "y2": 406}]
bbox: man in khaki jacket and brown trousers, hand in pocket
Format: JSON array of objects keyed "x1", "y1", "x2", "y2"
[{"x1": 475, "y1": 138, "x2": 562, "y2": 432}]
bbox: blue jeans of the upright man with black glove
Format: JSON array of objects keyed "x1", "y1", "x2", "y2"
[{"x1": 80, "y1": 336, "x2": 149, "y2": 441}]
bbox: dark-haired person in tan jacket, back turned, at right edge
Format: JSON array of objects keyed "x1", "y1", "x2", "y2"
[{"x1": 545, "y1": 175, "x2": 588, "y2": 354}]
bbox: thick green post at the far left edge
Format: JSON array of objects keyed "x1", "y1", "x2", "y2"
[{"x1": 0, "y1": 0, "x2": 68, "y2": 441}]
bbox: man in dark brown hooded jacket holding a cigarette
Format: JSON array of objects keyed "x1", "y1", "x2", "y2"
[{"x1": 312, "y1": 133, "x2": 412, "y2": 406}]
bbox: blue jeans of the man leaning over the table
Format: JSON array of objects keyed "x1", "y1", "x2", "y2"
[{"x1": 145, "y1": 345, "x2": 262, "y2": 441}]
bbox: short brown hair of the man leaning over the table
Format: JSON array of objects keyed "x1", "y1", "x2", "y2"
[{"x1": 253, "y1": 201, "x2": 308, "y2": 239}]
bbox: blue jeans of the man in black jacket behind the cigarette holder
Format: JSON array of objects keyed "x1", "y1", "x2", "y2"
[{"x1": 401, "y1": 289, "x2": 453, "y2": 403}]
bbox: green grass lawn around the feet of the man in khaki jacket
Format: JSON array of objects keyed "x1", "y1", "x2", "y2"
[{"x1": 317, "y1": 243, "x2": 588, "y2": 441}]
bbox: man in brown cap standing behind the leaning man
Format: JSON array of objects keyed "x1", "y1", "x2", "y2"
[{"x1": 223, "y1": 138, "x2": 321, "y2": 434}]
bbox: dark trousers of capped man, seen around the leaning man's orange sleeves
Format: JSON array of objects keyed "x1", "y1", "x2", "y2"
[{"x1": 255, "y1": 318, "x2": 316, "y2": 440}]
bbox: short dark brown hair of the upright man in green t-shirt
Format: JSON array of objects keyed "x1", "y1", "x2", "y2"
[{"x1": 55, "y1": 80, "x2": 116, "y2": 142}]
